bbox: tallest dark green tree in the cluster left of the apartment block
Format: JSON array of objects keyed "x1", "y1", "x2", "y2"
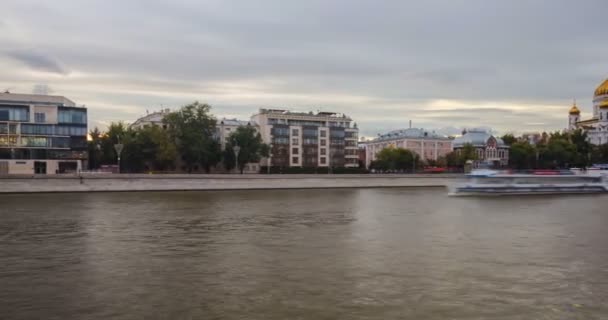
[{"x1": 163, "y1": 101, "x2": 220, "y2": 172}]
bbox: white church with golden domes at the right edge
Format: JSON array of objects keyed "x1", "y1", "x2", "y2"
[{"x1": 568, "y1": 79, "x2": 608, "y2": 145}]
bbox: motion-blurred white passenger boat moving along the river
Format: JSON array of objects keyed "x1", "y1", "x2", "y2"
[{"x1": 449, "y1": 169, "x2": 608, "y2": 196}]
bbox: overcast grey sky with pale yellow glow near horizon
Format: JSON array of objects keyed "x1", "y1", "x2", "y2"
[{"x1": 0, "y1": 0, "x2": 608, "y2": 136}]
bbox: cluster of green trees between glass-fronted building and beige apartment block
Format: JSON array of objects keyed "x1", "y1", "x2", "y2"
[{"x1": 88, "y1": 101, "x2": 269, "y2": 173}]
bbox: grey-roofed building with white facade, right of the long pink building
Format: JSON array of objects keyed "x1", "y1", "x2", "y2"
[{"x1": 452, "y1": 129, "x2": 509, "y2": 166}]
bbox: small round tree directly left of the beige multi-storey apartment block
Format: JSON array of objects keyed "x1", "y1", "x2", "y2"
[{"x1": 224, "y1": 126, "x2": 270, "y2": 173}]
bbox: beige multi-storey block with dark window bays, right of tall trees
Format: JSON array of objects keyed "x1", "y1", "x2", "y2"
[{"x1": 251, "y1": 109, "x2": 359, "y2": 167}]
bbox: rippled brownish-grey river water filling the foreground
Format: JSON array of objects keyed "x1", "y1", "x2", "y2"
[{"x1": 0, "y1": 189, "x2": 608, "y2": 319}]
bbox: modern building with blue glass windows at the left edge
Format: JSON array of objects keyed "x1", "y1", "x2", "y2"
[{"x1": 0, "y1": 93, "x2": 88, "y2": 174}]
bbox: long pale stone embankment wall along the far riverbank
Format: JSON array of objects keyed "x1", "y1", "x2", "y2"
[{"x1": 0, "y1": 174, "x2": 461, "y2": 193}]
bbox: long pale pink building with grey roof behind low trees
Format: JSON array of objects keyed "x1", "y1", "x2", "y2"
[{"x1": 365, "y1": 128, "x2": 452, "y2": 168}]
